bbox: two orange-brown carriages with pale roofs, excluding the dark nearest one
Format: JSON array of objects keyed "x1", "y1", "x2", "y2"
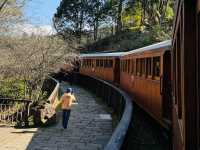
[{"x1": 80, "y1": 40, "x2": 172, "y2": 129}]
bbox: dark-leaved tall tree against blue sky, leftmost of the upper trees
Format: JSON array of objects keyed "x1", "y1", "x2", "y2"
[{"x1": 53, "y1": 0, "x2": 87, "y2": 42}]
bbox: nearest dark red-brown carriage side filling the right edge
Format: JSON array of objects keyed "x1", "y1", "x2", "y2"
[{"x1": 172, "y1": 0, "x2": 200, "y2": 150}]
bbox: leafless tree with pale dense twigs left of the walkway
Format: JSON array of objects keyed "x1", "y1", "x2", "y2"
[{"x1": 0, "y1": 36, "x2": 77, "y2": 100}]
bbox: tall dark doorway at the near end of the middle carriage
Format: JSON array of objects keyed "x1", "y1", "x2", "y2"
[{"x1": 161, "y1": 51, "x2": 172, "y2": 123}]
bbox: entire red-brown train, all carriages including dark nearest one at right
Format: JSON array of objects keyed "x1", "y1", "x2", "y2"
[{"x1": 80, "y1": 0, "x2": 200, "y2": 150}]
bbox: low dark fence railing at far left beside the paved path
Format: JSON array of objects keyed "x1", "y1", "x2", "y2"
[{"x1": 0, "y1": 98, "x2": 32, "y2": 126}]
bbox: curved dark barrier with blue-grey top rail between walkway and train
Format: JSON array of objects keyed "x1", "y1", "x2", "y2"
[{"x1": 65, "y1": 73, "x2": 133, "y2": 150}]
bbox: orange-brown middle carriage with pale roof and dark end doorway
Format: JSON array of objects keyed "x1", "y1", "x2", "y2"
[{"x1": 120, "y1": 41, "x2": 171, "y2": 128}]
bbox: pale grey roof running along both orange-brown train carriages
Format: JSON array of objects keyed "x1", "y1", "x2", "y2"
[{"x1": 80, "y1": 40, "x2": 172, "y2": 58}]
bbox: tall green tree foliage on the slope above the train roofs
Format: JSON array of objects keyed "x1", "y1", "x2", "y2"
[{"x1": 54, "y1": 0, "x2": 174, "y2": 48}]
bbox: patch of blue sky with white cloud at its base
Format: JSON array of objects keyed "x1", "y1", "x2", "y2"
[{"x1": 18, "y1": 0, "x2": 60, "y2": 36}]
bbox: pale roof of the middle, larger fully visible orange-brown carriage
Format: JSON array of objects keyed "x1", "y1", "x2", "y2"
[{"x1": 122, "y1": 40, "x2": 172, "y2": 56}]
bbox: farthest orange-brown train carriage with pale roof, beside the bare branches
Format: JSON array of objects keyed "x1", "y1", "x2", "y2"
[{"x1": 80, "y1": 52, "x2": 123, "y2": 84}]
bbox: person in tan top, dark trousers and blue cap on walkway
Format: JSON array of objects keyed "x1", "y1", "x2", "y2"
[{"x1": 61, "y1": 88, "x2": 76, "y2": 129}]
